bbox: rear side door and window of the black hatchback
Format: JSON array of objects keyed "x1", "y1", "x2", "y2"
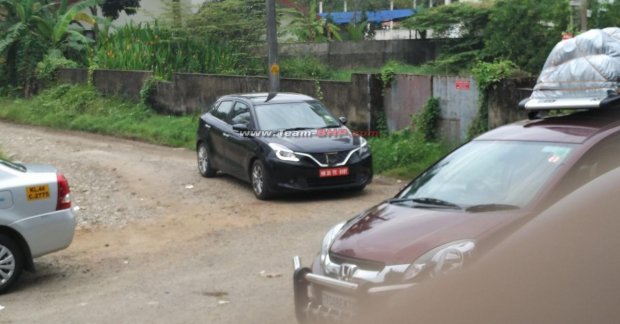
[{"x1": 205, "y1": 100, "x2": 234, "y2": 173}]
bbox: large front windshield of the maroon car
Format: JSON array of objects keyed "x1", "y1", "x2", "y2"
[{"x1": 397, "y1": 141, "x2": 575, "y2": 211}]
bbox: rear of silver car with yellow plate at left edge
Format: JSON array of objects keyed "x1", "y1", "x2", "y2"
[{"x1": 0, "y1": 159, "x2": 75, "y2": 293}]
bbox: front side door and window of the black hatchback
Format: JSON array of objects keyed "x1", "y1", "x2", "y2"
[{"x1": 226, "y1": 101, "x2": 257, "y2": 179}]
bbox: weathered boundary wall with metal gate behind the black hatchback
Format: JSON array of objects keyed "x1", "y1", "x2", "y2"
[{"x1": 57, "y1": 69, "x2": 535, "y2": 143}]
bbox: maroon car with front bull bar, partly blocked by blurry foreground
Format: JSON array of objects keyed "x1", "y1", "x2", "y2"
[{"x1": 294, "y1": 109, "x2": 620, "y2": 322}]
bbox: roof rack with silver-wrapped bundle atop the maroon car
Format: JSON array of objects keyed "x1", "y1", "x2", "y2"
[{"x1": 519, "y1": 27, "x2": 620, "y2": 111}]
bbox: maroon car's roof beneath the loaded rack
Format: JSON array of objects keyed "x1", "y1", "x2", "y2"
[{"x1": 477, "y1": 108, "x2": 620, "y2": 143}]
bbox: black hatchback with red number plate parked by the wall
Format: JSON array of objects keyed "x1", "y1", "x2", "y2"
[{"x1": 196, "y1": 93, "x2": 373, "y2": 199}]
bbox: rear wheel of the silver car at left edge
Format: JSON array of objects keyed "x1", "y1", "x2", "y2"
[{"x1": 0, "y1": 234, "x2": 24, "y2": 294}]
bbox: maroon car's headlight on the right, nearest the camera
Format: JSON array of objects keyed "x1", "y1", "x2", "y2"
[{"x1": 404, "y1": 240, "x2": 476, "y2": 280}]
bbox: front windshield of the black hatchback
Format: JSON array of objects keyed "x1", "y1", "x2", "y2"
[{"x1": 255, "y1": 101, "x2": 340, "y2": 130}]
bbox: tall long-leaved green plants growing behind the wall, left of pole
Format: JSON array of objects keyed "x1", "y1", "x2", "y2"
[{"x1": 95, "y1": 23, "x2": 257, "y2": 78}]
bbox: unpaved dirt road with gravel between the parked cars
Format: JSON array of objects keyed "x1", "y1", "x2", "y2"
[{"x1": 0, "y1": 122, "x2": 402, "y2": 324}]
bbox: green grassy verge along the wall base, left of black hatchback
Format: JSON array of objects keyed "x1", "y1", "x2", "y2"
[{"x1": 0, "y1": 85, "x2": 197, "y2": 148}]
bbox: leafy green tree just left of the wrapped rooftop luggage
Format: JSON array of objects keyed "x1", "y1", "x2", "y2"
[{"x1": 482, "y1": 0, "x2": 570, "y2": 73}]
